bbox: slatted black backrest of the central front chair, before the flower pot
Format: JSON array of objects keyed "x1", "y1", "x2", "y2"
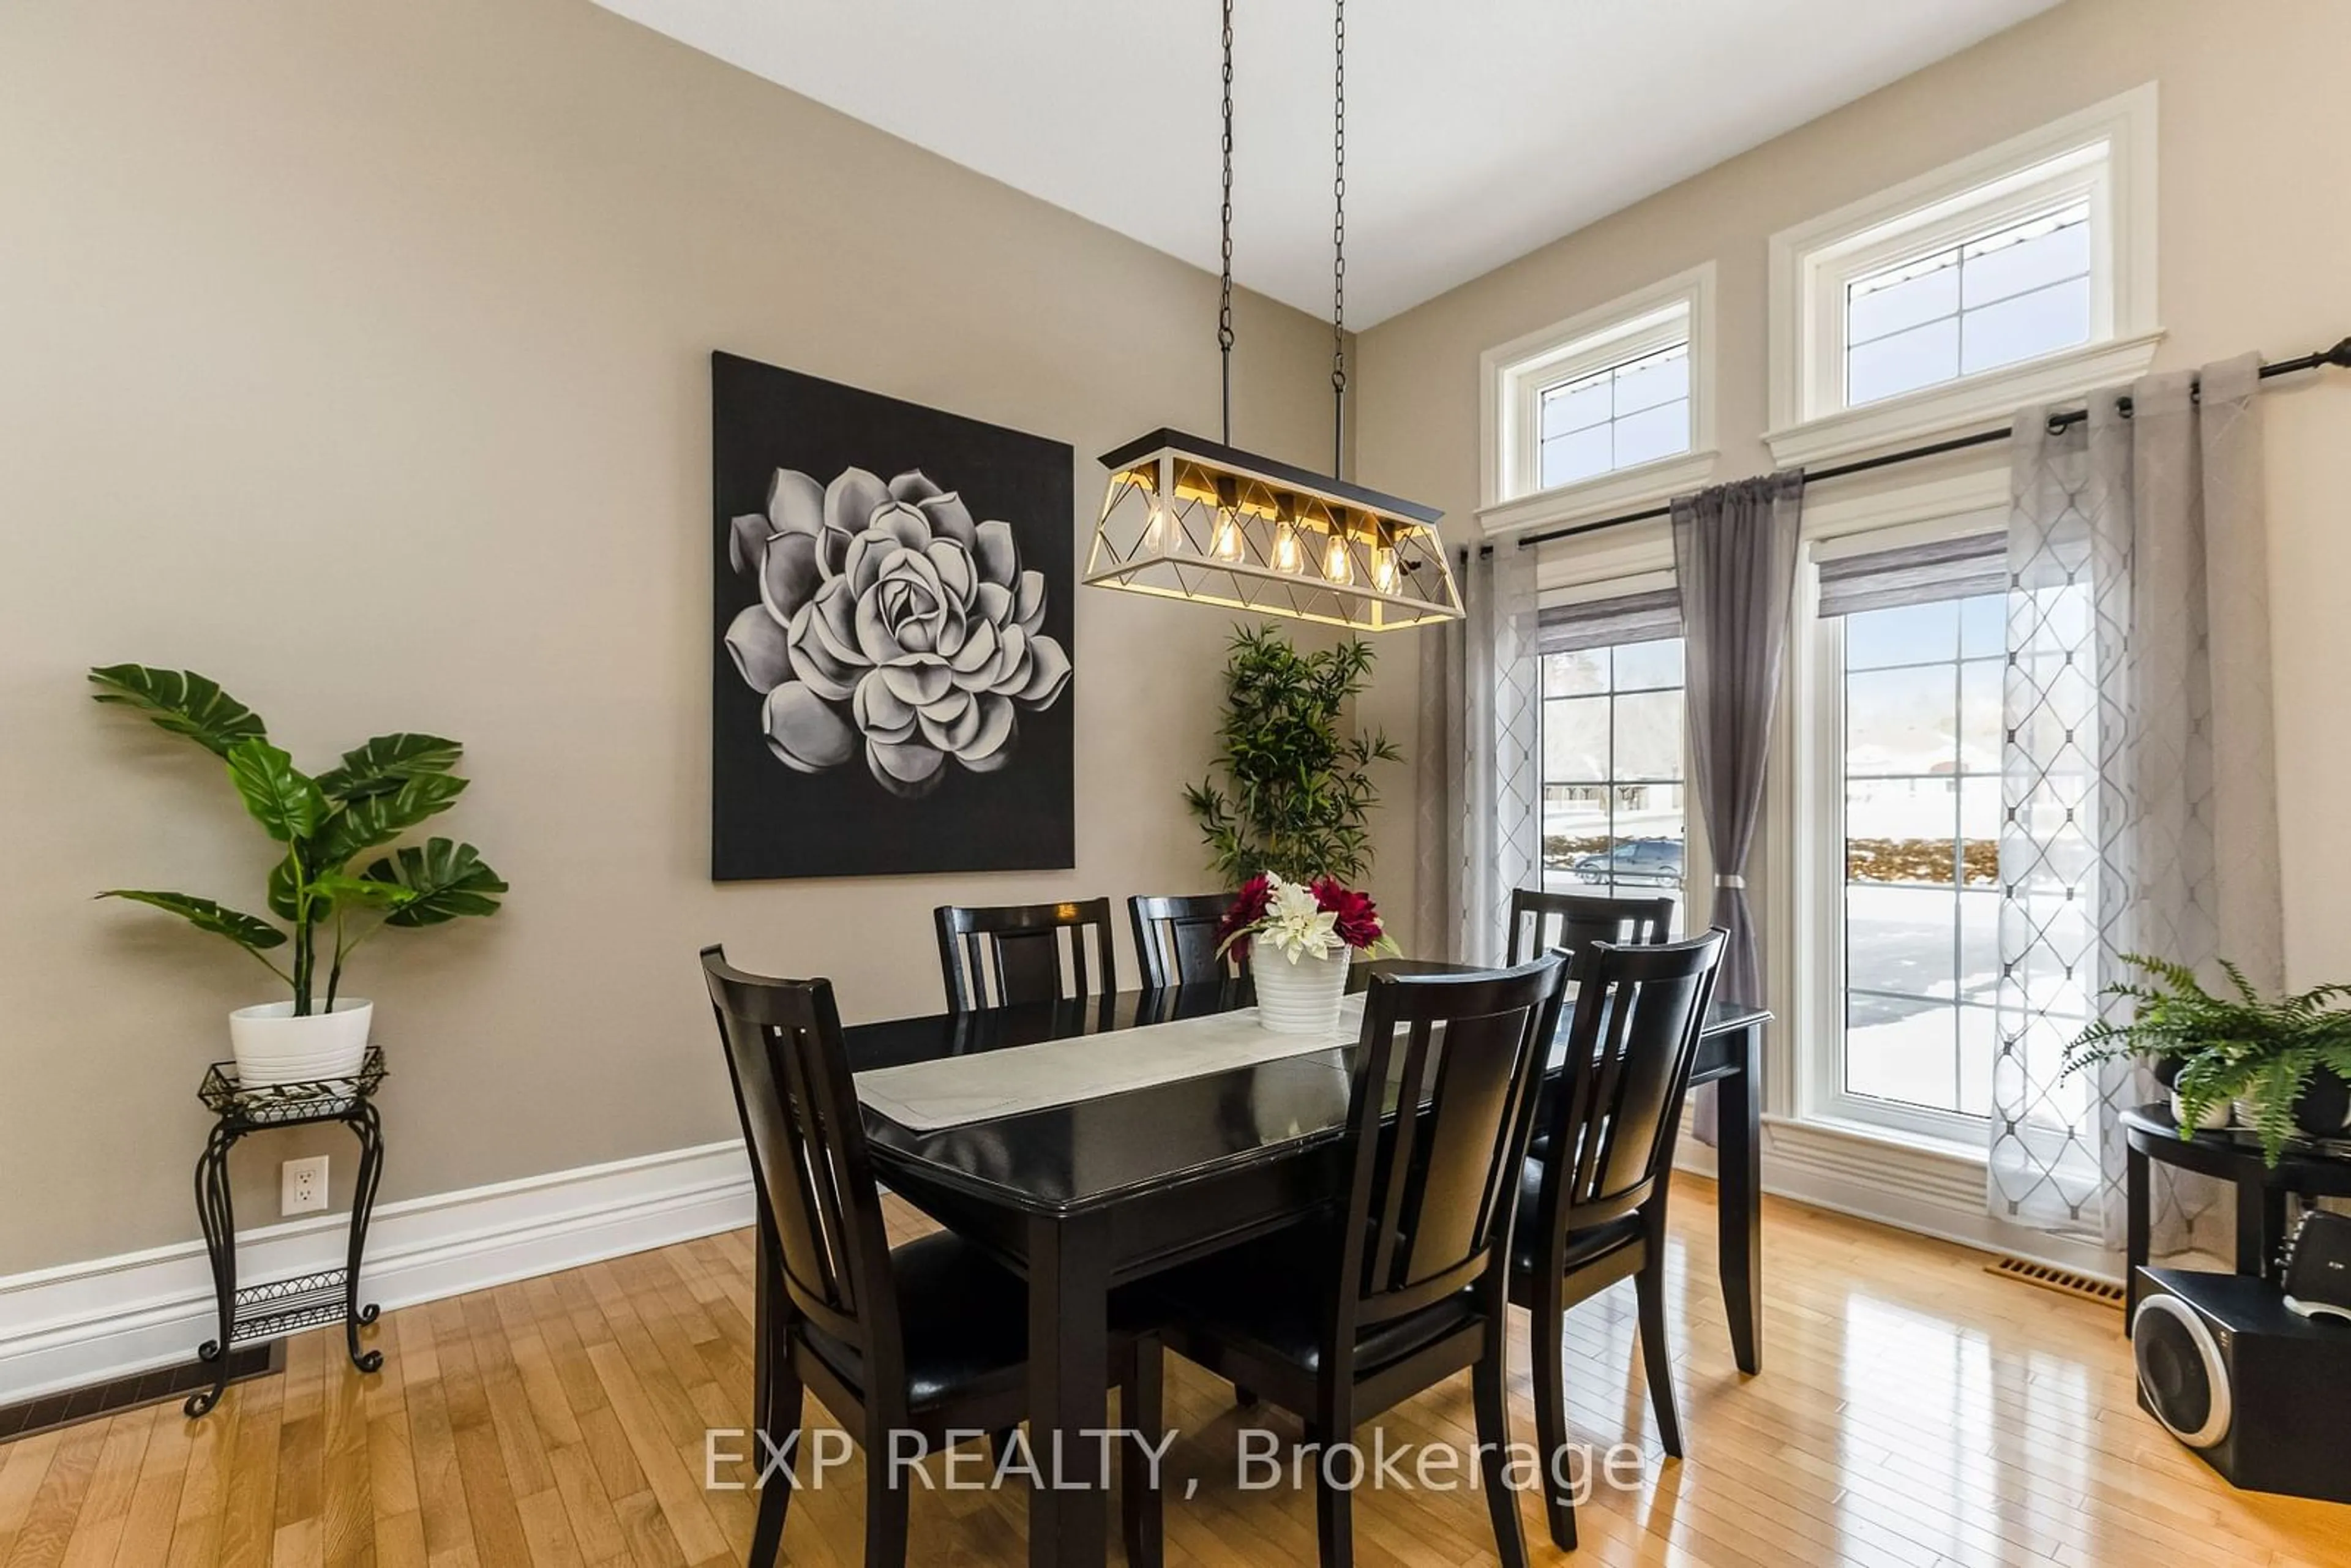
[{"x1": 1338, "y1": 957, "x2": 1565, "y2": 1347}]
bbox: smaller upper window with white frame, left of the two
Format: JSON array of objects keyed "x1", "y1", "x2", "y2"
[{"x1": 1479, "y1": 263, "x2": 1714, "y2": 534}]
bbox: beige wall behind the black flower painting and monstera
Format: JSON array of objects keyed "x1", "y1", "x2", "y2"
[{"x1": 0, "y1": 0, "x2": 1363, "y2": 1274}]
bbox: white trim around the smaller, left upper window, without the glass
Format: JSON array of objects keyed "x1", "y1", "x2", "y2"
[{"x1": 1477, "y1": 261, "x2": 1716, "y2": 538}]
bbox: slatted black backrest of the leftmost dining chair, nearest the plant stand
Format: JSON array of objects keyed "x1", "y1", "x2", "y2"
[{"x1": 703, "y1": 947, "x2": 905, "y2": 1389}]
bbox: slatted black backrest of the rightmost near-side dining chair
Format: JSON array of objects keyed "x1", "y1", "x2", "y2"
[{"x1": 1528, "y1": 929, "x2": 1723, "y2": 1239}]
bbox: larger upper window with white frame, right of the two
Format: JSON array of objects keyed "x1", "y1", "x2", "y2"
[{"x1": 1766, "y1": 84, "x2": 2161, "y2": 463}]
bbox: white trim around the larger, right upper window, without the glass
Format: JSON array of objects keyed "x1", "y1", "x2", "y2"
[{"x1": 1763, "y1": 82, "x2": 2163, "y2": 468}]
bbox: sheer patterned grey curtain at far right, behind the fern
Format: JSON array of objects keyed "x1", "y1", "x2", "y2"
[{"x1": 1987, "y1": 355, "x2": 2283, "y2": 1253}]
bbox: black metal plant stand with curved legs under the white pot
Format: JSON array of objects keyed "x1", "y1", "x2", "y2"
[{"x1": 186, "y1": 1046, "x2": 383, "y2": 1417}]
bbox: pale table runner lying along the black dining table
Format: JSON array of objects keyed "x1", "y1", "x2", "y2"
[{"x1": 856, "y1": 997, "x2": 1363, "y2": 1133}]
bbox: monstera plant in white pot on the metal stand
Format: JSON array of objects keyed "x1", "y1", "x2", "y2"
[{"x1": 89, "y1": 666, "x2": 506, "y2": 1086}]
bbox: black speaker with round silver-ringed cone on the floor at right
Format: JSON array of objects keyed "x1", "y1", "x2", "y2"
[{"x1": 2130, "y1": 1269, "x2": 2351, "y2": 1502}]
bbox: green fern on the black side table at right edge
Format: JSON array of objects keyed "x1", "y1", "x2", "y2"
[{"x1": 2064, "y1": 955, "x2": 2351, "y2": 1166}]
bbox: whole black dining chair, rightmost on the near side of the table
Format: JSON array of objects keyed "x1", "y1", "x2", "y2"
[{"x1": 1509, "y1": 929, "x2": 1723, "y2": 1549}]
